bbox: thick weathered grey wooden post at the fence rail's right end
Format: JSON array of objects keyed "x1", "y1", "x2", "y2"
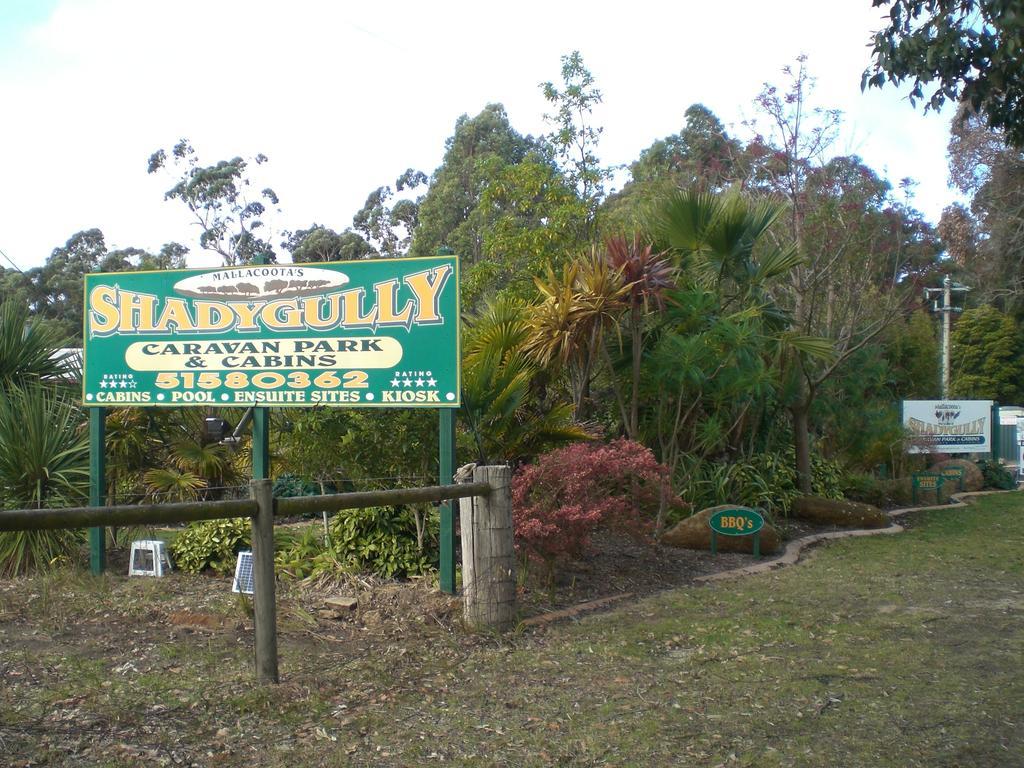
[{"x1": 460, "y1": 467, "x2": 515, "y2": 630}]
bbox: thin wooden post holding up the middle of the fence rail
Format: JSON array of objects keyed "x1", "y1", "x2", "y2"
[{"x1": 251, "y1": 478, "x2": 279, "y2": 683}]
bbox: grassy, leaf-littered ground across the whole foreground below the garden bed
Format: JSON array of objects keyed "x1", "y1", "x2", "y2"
[{"x1": 0, "y1": 494, "x2": 1024, "y2": 768}]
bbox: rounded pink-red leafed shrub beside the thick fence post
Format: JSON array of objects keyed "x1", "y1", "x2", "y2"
[{"x1": 512, "y1": 437, "x2": 682, "y2": 574}]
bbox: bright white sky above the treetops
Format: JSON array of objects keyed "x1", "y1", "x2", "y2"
[{"x1": 0, "y1": 0, "x2": 954, "y2": 268}]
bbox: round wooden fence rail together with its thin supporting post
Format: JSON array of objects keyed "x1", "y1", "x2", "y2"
[{"x1": 0, "y1": 480, "x2": 494, "y2": 683}]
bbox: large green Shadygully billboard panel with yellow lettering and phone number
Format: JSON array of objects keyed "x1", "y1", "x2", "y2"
[{"x1": 83, "y1": 256, "x2": 460, "y2": 409}]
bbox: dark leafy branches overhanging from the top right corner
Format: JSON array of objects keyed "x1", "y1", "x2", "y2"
[{"x1": 861, "y1": 0, "x2": 1024, "y2": 147}]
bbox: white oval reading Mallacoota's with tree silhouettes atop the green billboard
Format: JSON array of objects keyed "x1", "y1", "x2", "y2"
[{"x1": 174, "y1": 264, "x2": 348, "y2": 301}]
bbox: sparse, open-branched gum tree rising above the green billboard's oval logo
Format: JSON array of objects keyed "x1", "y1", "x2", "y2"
[{"x1": 147, "y1": 138, "x2": 280, "y2": 266}]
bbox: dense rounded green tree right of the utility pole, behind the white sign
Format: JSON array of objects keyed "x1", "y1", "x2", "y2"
[{"x1": 949, "y1": 306, "x2": 1024, "y2": 403}]
